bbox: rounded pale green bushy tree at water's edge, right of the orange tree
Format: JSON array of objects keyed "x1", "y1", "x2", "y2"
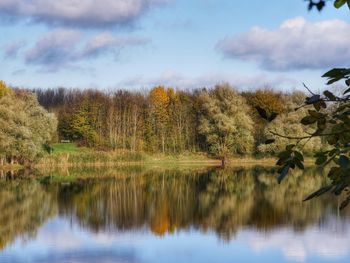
[{"x1": 198, "y1": 84, "x2": 254, "y2": 165}]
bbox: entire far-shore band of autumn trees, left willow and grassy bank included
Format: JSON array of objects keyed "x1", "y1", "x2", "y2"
[{"x1": 0, "y1": 79, "x2": 332, "y2": 168}]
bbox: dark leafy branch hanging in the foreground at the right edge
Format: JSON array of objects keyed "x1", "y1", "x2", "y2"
[{"x1": 265, "y1": 68, "x2": 350, "y2": 209}]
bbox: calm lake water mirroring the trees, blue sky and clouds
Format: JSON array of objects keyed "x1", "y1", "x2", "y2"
[{"x1": 0, "y1": 168, "x2": 350, "y2": 263}]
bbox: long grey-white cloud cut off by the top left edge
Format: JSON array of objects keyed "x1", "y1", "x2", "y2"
[{"x1": 0, "y1": 0, "x2": 168, "y2": 27}]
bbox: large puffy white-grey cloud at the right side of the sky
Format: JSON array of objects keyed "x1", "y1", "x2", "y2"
[{"x1": 216, "y1": 17, "x2": 350, "y2": 70}]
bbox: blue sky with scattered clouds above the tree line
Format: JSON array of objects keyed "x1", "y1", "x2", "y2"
[{"x1": 0, "y1": 0, "x2": 350, "y2": 91}]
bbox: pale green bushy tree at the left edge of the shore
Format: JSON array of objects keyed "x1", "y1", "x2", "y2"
[{"x1": 0, "y1": 86, "x2": 57, "y2": 164}]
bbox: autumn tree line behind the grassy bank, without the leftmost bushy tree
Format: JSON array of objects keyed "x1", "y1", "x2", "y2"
[{"x1": 34, "y1": 84, "x2": 324, "y2": 161}]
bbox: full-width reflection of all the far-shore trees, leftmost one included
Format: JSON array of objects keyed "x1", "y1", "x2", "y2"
[{"x1": 0, "y1": 167, "x2": 348, "y2": 252}]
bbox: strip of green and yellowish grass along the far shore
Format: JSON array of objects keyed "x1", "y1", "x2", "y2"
[{"x1": 0, "y1": 143, "x2": 313, "y2": 170}]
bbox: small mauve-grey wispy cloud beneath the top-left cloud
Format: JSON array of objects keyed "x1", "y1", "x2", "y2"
[{"x1": 25, "y1": 28, "x2": 148, "y2": 71}]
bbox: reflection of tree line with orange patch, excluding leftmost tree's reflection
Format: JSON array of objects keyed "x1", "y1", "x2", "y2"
[{"x1": 50, "y1": 168, "x2": 348, "y2": 240}]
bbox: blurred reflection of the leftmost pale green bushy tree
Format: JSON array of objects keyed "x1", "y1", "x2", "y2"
[{"x1": 0, "y1": 179, "x2": 58, "y2": 250}]
